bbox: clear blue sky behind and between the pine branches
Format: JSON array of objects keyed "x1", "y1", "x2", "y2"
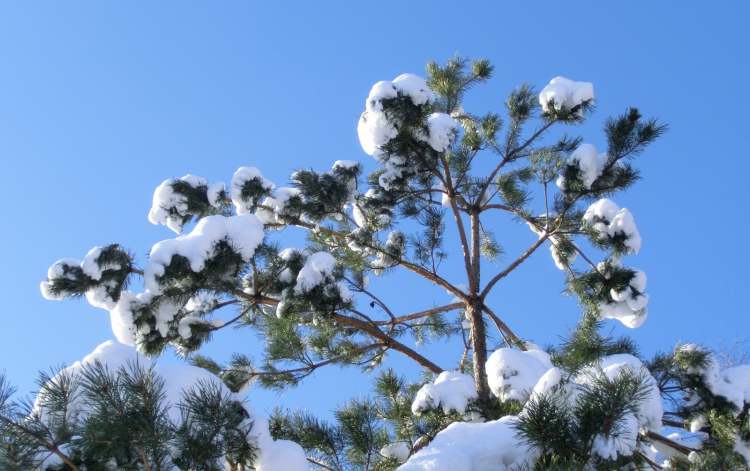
[{"x1": 0, "y1": 1, "x2": 750, "y2": 420}]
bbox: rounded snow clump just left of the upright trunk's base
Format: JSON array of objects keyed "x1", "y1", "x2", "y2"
[{"x1": 411, "y1": 371, "x2": 477, "y2": 414}]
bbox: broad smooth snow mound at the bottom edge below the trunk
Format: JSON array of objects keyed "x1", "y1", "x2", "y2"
[{"x1": 397, "y1": 416, "x2": 535, "y2": 471}]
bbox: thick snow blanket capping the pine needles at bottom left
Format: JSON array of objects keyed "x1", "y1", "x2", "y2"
[{"x1": 34, "y1": 340, "x2": 309, "y2": 471}]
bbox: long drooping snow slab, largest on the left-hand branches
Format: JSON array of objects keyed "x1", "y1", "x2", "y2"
[{"x1": 144, "y1": 214, "x2": 263, "y2": 294}]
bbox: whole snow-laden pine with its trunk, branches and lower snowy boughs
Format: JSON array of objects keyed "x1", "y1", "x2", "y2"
[{"x1": 0, "y1": 59, "x2": 750, "y2": 471}]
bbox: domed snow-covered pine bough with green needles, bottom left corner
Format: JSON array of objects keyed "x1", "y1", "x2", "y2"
[{"x1": 0, "y1": 341, "x2": 309, "y2": 471}]
